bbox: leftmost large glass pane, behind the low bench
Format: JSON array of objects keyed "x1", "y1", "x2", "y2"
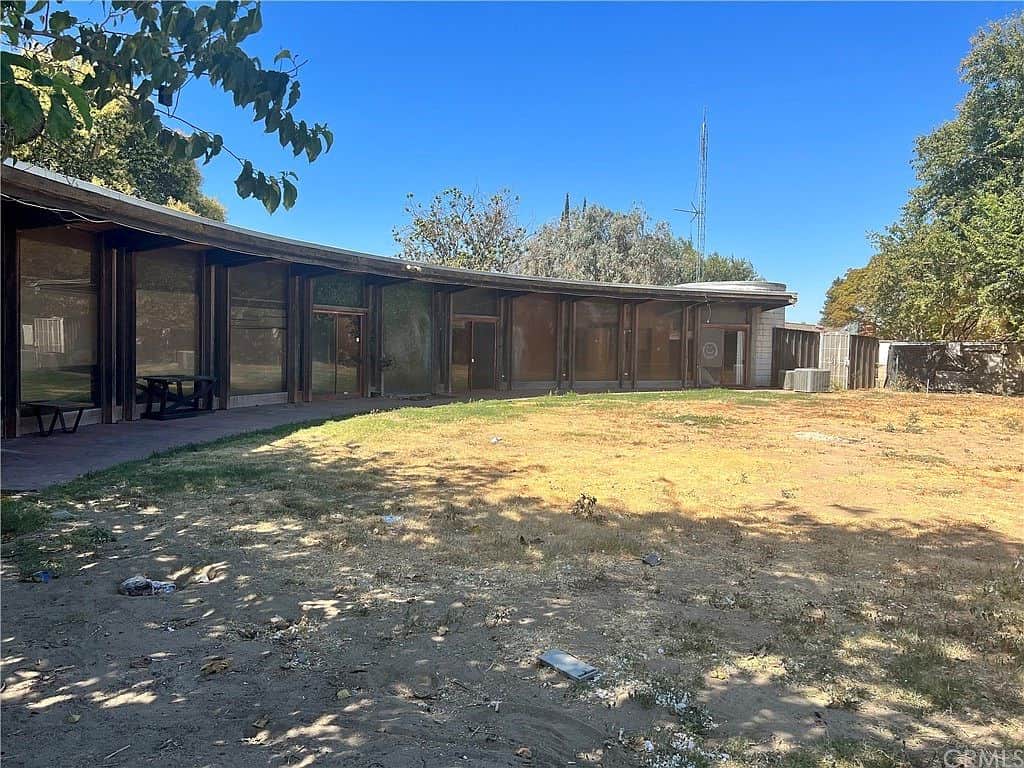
[{"x1": 18, "y1": 228, "x2": 99, "y2": 406}]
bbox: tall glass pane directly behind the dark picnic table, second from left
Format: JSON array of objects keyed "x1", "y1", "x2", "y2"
[{"x1": 135, "y1": 249, "x2": 199, "y2": 376}]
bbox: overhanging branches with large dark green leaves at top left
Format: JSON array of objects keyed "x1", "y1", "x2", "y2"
[{"x1": 0, "y1": 0, "x2": 334, "y2": 212}]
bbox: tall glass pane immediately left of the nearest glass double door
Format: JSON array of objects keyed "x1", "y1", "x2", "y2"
[{"x1": 230, "y1": 262, "x2": 288, "y2": 395}]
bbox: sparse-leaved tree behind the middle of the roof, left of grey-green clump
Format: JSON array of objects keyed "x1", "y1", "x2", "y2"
[{"x1": 393, "y1": 187, "x2": 526, "y2": 272}]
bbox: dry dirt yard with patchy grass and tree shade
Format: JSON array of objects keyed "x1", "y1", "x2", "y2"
[{"x1": 2, "y1": 391, "x2": 1024, "y2": 768}]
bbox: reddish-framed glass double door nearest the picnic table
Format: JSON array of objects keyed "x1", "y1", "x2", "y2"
[{"x1": 312, "y1": 312, "x2": 364, "y2": 399}]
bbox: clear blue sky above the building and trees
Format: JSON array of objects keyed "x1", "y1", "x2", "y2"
[{"x1": 174, "y1": 2, "x2": 1020, "y2": 321}]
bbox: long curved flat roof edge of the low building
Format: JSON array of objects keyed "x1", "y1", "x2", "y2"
[{"x1": 0, "y1": 161, "x2": 797, "y2": 307}]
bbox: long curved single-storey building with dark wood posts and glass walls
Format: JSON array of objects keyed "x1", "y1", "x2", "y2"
[{"x1": 0, "y1": 165, "x2": 796, "y2": 437}]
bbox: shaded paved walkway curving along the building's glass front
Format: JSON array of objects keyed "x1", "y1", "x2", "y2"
[{"x1": 0, "y1": 397, "x2": 452, "y2": 490}]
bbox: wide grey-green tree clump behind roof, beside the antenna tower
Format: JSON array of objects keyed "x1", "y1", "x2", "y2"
[{"x1": 521, "y1": 204, "x2": 757, "y2": 285}]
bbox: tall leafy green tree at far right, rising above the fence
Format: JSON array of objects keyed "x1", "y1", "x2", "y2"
[{"x1": 822, "y1": 13, "x2": 1024, "y2": 340}]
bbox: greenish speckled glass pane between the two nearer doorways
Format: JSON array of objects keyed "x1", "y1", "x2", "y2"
[{"x1": 381, "y1": 282, "x2": 433, "y2": 394}]
